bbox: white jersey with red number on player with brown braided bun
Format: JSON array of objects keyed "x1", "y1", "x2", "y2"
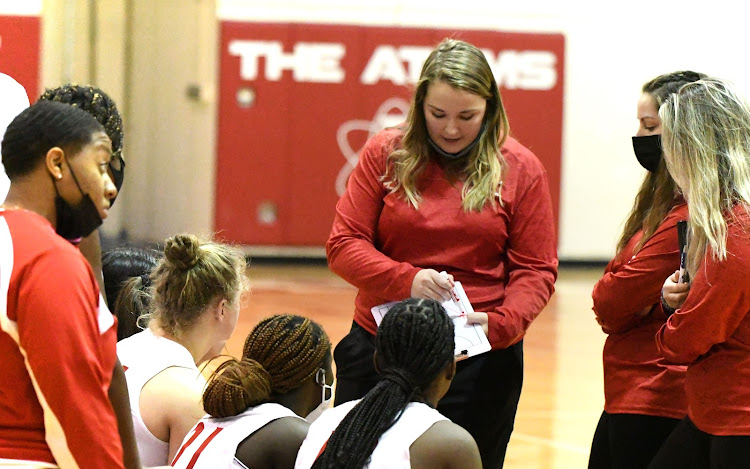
[{"x1": 172, "y1": 403, "x2": 301, "y2": 469}]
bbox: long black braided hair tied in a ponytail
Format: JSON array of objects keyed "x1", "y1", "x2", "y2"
[{"x1": 312, "y1": 298, "x2": 454, "y2": 469}]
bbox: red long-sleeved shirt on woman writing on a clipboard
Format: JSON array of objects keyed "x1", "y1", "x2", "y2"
[{"x1": 326, "y1": 129, "x2": 557, "y2": 349}]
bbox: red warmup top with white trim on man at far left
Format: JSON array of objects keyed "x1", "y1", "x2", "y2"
[{"x1": 0, "y1": 210, "x2": 123, "y2": 469}]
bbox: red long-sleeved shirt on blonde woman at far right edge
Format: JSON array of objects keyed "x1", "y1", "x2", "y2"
[{"x1": 656, "y1": 206, "x2": 750, "y2": 436}]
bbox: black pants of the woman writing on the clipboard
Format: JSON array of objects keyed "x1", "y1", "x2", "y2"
[{"x1": 333, "y1": 323, "x2": 523, "y2": 469}]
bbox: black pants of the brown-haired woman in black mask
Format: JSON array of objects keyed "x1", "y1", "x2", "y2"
[{"x1": 589, "y1": 412, "x2": 680, "y2": 469}]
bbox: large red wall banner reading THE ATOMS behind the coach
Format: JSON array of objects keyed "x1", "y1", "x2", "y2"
[{"x1": 215, "y1": 21, "x2": 565, "y2": 246}]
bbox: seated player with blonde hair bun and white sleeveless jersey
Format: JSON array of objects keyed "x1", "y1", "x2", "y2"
[{"x1": 117, "y1": 234, "x2": 247, "y2": 466}]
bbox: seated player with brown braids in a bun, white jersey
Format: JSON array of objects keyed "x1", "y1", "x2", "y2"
[{"x1": 172, "y1": 314, "x2": 333, "y2": 469}]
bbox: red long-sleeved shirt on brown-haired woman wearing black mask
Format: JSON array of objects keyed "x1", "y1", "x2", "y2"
[{"x1": 592, "y1": 203, "x2": 687, "y2": 419}]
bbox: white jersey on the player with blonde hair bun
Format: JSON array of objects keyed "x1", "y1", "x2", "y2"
[{"x1": 117, "y1": 329, "x2": 200, "y2": 467}]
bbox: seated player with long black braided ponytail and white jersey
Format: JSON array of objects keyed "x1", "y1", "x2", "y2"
[{"x1": 295, "y1": 298, "x2": 482, "y2": 469}]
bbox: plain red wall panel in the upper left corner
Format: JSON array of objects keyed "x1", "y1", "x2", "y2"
[{"x1": 0, "y1": 15, "x2": 41, "y2": 103}]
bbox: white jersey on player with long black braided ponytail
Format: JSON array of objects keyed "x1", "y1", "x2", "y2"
[{"x1": 294, "y1": 400, "x2": 448, "y2": 469}]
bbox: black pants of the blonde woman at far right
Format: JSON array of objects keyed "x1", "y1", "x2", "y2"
[{"x1": 648, "y1": 417, "x2": 750, "y2": 469}]
